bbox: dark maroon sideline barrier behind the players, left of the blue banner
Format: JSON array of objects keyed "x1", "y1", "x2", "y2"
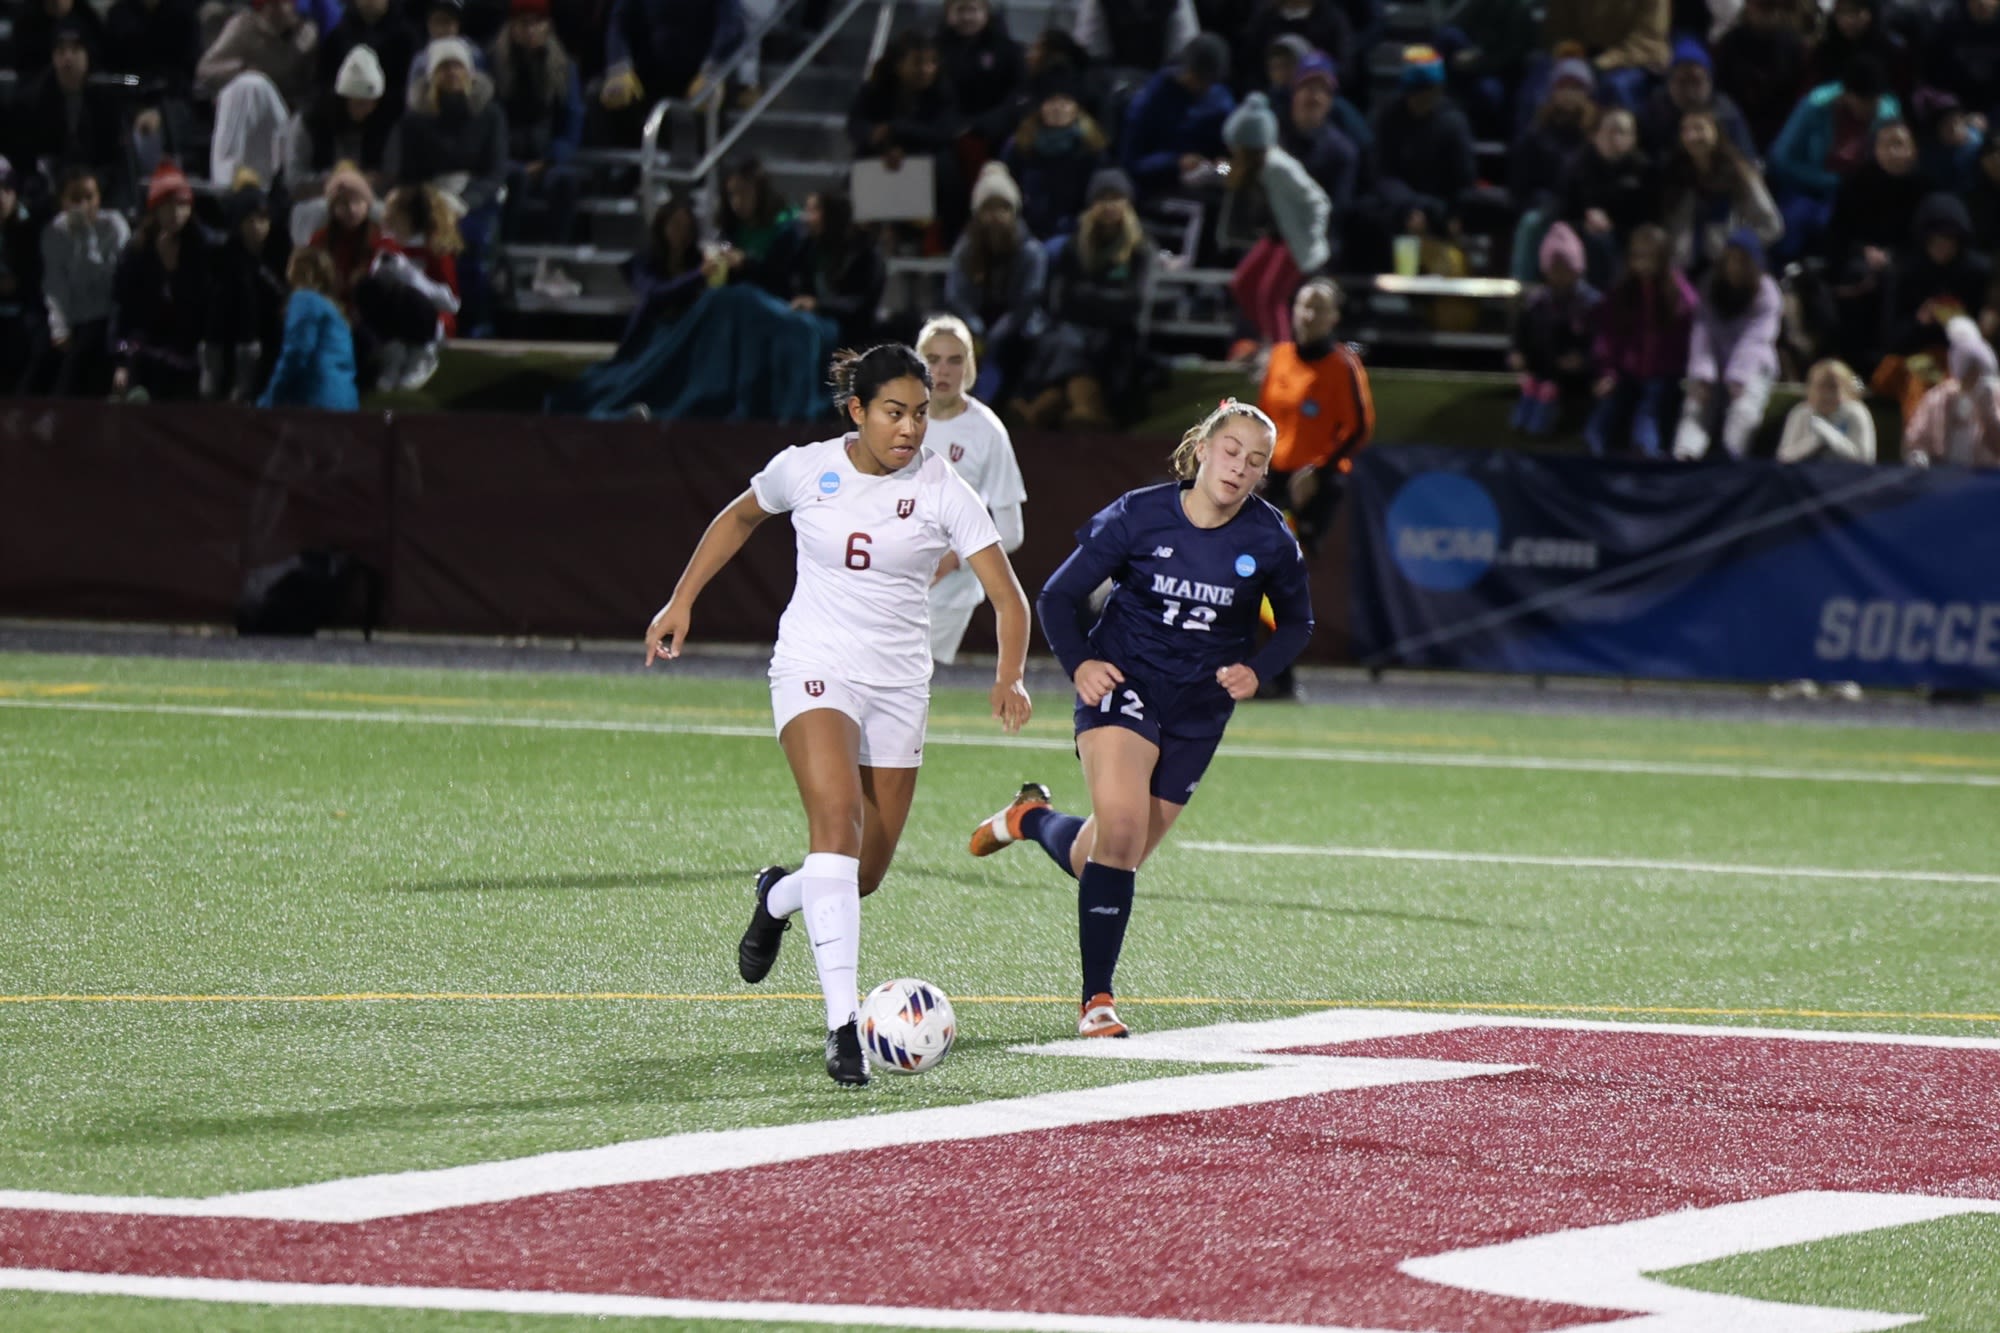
[{"x1": 0, "y1": 402, "x2": 1348, "y2": 660}]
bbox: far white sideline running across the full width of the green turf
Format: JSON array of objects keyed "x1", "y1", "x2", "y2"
[{"x1": 0, "y1": 699, "x2": 2000, "y2": 789}]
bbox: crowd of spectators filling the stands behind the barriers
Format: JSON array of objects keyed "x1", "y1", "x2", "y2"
[{"x1": 0, "y1": 0, "x2": 2000, "y2": 458}]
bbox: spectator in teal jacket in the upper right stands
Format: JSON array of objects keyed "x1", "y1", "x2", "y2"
[{"x1": 1766, "y1": 54, "x2": 1902, "y2": 258}]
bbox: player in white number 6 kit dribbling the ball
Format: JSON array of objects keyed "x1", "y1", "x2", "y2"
[{"x1": 646, "y1": 344, "x2": 1030, "y2": 1085}]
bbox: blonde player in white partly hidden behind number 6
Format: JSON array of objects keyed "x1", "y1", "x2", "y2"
[{"x1": 916, "y1": 314, "x2": 1028, "y2": 664}]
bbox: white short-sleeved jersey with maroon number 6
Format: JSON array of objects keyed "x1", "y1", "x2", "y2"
[{"x1": 750, "y1": 436, "x2": 1000, "y2": 685}]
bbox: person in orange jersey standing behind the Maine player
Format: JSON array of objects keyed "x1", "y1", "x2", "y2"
[{"x1": 1258, "y1": 278, "x2": 1374, "y2": 554}]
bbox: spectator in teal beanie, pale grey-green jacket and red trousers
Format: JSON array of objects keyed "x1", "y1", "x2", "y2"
[{"x1": 1216, "y1": 92, "x2": 1334, "y2": 358}]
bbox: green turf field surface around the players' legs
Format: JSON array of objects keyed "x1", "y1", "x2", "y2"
[{"x1": 0, "y1": 656, "x2": 2000, "y2": 1331}]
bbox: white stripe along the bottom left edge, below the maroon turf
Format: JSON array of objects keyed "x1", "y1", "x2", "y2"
[{"x1": 0, "y1": 1269, "x2": 1408, "y2": 1333}]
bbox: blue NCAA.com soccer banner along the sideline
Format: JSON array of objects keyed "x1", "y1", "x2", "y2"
[{"x1": 1348, "y1": 448, "x2": 2000, "y2": 689}]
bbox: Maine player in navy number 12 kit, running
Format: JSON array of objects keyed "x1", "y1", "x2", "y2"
[{"x1": 972, "y1": 398, "x2": 1312, "y2": 1037}]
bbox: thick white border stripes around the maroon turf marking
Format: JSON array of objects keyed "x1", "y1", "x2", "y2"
[{"x1": 0, "y1": 1011, "x2": 2000, "y2": 1333}]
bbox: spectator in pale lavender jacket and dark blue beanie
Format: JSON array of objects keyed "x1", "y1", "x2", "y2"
[{"x1": 1674, "y1": 226, "x2": 1784, "y2": 462}]
